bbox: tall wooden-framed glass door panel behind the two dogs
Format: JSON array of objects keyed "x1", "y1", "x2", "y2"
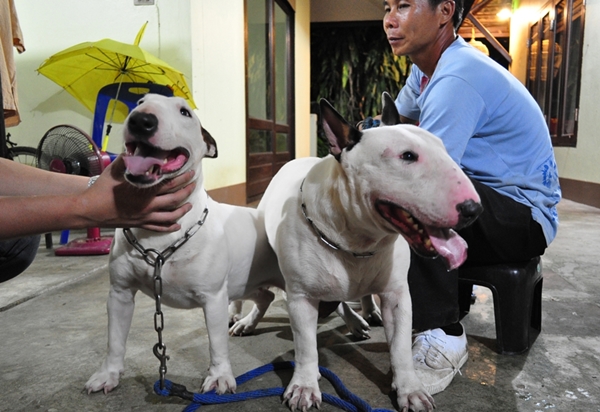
[{"x1": 246, "y1": 0, "x2": 294, "y2": 202}]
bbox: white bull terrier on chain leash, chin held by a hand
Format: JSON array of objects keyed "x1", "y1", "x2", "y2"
[{"x1": 85, "y1": 94, "x2": 284, "y2": 394}]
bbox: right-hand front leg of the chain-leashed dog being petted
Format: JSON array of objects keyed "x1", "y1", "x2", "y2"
[{"x1": 202, "y1": 286, "x2": 236, "y2": 395}]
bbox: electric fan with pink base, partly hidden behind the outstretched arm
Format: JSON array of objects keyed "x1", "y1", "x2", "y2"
[{"x1": 37, "y1": 125, "x2": 112, "y2": 256}]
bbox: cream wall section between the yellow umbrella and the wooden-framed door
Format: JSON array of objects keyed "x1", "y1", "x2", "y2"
[{"x1": 191, "y1": 0, "x2": 246, "y2": 190}]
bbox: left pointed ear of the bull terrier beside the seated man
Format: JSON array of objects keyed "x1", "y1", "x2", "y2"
[{"x1": 319, "y1": 99, "x2": 362, "y2": 160}]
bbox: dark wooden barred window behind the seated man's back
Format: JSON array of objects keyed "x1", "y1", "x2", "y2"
[{"x1": 527, "y1": 0, "x2": 585, "y2": 147}]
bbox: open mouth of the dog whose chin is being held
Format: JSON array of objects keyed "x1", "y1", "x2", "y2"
[{"x1": 124, "y1": 142, "x2": 190, "y2": 184}]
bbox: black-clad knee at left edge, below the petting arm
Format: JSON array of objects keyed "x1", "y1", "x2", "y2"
[{"x1": 0, "y1": 236, "x2": 41, "y2": 282}]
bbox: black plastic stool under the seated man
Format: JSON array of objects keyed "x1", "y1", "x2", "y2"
[{"x1": 458, "y1": 257, "x2": 543, "y2": 355}]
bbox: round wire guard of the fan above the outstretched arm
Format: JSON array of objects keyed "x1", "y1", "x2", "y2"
[{"x1": 37, "y1": 125, "x2": 103, "y2": 176}]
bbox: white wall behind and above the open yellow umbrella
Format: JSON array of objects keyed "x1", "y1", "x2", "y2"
[{"x1": 7, "y1": 0, "x2": 191, "y2": 151}]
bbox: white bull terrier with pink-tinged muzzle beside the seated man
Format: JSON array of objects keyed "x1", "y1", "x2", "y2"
[{"x1": 258, "y1": 93, "x2": 481, "y2": 411}]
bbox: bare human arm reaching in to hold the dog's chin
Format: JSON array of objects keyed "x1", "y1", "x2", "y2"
[{"x1": 0, "y1": 156, "x2": 195, "y2": 240}]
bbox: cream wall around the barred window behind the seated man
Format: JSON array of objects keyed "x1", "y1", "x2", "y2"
[{"x1": 510, "y1": 0, "x2": 600, "y2": 183}]
